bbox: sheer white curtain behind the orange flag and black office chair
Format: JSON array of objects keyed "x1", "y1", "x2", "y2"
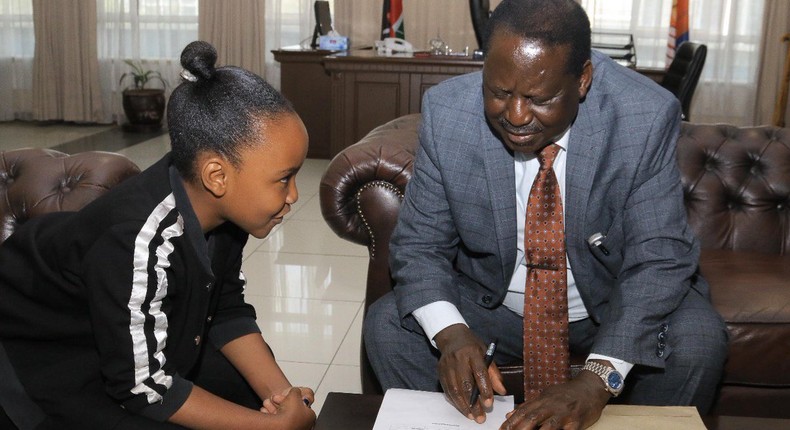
[{"x1": 581, "y1": 0, "x2": 764, "y2": 125}]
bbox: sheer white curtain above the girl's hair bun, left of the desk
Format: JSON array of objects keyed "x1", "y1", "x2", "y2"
[{"x1": 264, "y1": 0, "x2": 332, "y2": 89}]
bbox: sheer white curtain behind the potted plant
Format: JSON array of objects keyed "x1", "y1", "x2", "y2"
[{"x1": 97, "y1": 0, "x2": 198, "y2": 123}]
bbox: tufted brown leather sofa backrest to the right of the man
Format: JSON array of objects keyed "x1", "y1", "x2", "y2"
[{"x1": 677, "y1": 123, "x2": 790, "y2": 255}]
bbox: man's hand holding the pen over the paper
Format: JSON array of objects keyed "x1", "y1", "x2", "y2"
[{"x1": 434, "y1": 324, "x2": 505, "y2": 423}]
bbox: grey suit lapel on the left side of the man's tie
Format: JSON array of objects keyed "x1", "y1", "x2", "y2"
[{"x1": 480, "y1": 121, "x2": 517, "y2": 288}]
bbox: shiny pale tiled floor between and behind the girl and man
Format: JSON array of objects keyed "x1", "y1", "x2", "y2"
[{"x1": 0, "y1": 122, "x2": 367, "y2": 412}]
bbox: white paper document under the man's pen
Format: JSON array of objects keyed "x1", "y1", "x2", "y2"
[{"x1": 373, "y1": 388, "x2": 513, "y2": 430}]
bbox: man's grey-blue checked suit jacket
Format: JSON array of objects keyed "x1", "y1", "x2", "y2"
[{"x1": 390, "y1": 52, "x2": 708, "y2": 367}]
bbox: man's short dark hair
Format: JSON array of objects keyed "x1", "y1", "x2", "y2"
[{"x1": 485, "y1": 0, "x2": 591, "y2": 76}]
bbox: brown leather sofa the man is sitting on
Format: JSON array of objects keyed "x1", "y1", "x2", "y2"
[{"x1": 320, "y1": 114, "x2": 790, "y2": 418}]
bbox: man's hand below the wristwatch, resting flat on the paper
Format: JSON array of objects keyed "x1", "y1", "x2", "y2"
[{"x1": 500, "y1": 371, "x2": 612, "y2": 430}]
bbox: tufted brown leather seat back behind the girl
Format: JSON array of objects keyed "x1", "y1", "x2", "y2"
[{"x1": 0, "y1": 149, "x2": 140, "y2": 243}]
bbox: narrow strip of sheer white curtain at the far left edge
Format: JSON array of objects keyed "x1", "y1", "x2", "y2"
[{"x1": 0, "y1": 0, "x2": 35, "y2": 121}]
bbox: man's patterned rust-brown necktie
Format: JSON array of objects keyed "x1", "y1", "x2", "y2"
[{"x1": 524, "y1": 144, "x2": 570, "y2": 401}]
